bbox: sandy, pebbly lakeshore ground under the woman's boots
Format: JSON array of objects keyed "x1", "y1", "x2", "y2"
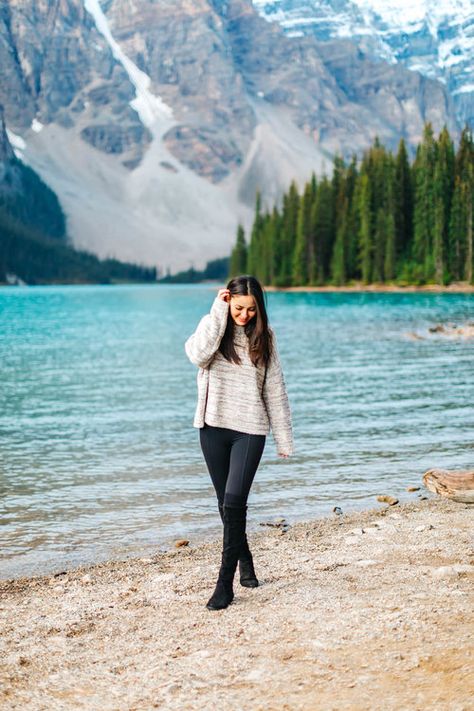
[{"x1": 0, "y1": 498, "x2": 474, "y2": 711}]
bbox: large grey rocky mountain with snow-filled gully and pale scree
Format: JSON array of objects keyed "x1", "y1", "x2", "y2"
[{"x1": 0, "y1": 0, "x2": 457, "y2": 270}]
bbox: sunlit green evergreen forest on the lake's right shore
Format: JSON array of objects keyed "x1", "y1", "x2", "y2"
[{"x1": 229, "y1": 123, "x2": 474, "y2": 287}]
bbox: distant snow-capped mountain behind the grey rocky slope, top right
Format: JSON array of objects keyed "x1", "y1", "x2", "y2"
[{"x1": 253, "y1": 0, "x2": 474, "y2": 125}]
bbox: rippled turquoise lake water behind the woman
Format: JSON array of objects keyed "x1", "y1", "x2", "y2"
[{"x1": 0, "y1": 284, "x2": 474, "y2": 578}]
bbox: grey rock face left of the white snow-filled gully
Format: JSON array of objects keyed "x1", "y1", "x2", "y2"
[{"x1": 0, "y1": 0, "x2": 150, "y2": 167}]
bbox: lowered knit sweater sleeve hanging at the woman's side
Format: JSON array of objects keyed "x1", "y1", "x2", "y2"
[{"x1": 263, "y1": 331, "x2": 293, "y2": 455}]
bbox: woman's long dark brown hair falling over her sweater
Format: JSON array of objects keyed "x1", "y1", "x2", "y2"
[{"x1": 219, "y1": 274, "x2": 272, "y2": 366}]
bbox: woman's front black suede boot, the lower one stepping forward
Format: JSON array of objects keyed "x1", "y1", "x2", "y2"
[{"x1": 206, "y1": 506, "x2": 245, "y2": 610}]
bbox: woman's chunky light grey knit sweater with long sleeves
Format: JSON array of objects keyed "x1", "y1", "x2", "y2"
[{"x1": 185, "y1": 297, "x2": 293, "y2": 455}]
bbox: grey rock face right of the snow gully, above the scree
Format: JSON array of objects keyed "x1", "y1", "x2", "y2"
[{"x1": 102, "y1": 0, "x2": 462, "y2": 182}]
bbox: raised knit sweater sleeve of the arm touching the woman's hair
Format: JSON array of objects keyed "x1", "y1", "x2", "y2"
[{"x1": 184, "y1": 296, "x2": 229, "y2": 368}]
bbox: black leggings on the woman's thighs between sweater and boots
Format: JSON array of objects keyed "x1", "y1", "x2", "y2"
[{"x1": 199, "y1": 424, "x2": 266, "y2": 508}]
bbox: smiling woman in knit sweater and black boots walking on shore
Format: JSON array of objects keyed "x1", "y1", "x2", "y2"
[{"x1": 185, "y1": 276, "x2": 293, "y2": 610}]
